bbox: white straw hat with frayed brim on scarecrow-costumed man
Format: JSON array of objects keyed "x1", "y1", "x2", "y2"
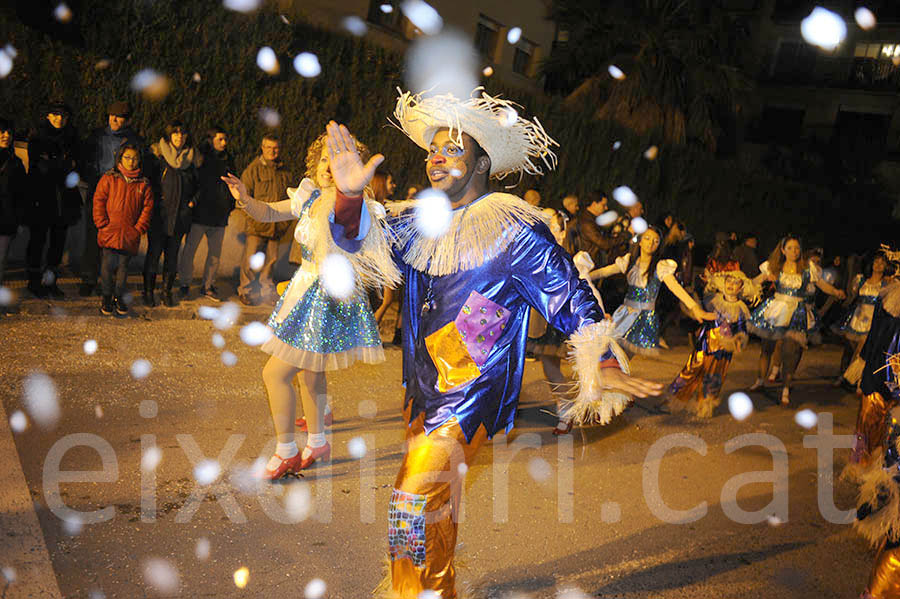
[{"x1": 392, "y1": 87, "x2": 559, "y2": 179}]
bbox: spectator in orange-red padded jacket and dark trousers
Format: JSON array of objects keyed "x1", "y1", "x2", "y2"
[{"x1": 94, "y1": 143, "x2": 153, "y2": 316}]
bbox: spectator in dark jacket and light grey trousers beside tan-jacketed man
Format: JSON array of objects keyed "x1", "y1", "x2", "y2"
[{"x1": 178, "y1": 125, "x2": 235, "y2": 302}]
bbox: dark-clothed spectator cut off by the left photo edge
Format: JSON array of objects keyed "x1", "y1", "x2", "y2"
[{"x1": 0, "y1": 118, "x2": 28, "y2": 292}]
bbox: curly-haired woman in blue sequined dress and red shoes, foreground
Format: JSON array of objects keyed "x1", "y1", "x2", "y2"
[{"x1": 223, "y1": 134, "x2": 400, "y2": 480}]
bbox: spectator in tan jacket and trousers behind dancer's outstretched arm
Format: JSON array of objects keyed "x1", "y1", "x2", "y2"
[{"x1": 238, "y1": 134, "x2": 292, "y2": 306}]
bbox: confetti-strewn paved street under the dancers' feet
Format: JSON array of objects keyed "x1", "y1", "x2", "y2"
[{"x1": 0, "y1": 292, "x2": 873, "y2": 599}]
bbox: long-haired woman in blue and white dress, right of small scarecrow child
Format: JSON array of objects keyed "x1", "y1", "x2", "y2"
[{"x1": 747, "y1": 235, "x2": 844, "y2": 405}]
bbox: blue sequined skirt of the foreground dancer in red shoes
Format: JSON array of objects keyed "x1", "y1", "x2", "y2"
[{"x1": 261, "y1": 269, "x2": 384, "y2": 372}]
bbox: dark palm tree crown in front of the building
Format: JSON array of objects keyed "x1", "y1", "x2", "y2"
[{"x1": 543, "y1": 0, "x2": 752, "y2": 152}]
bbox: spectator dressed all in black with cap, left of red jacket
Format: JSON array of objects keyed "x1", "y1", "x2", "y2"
[{"x1": 25, "y1": 102, "x2": 81, "y2": 298}]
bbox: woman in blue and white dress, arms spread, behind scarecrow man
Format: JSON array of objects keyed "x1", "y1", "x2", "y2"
[{"x1": 590, "y1": 227, "x2": 716, "y2": 355}]
